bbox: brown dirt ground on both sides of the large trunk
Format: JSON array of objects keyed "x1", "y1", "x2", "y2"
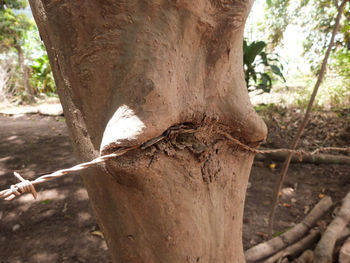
[{"x1": 0, "y1": 109, "x2": 350, "y2": 263}]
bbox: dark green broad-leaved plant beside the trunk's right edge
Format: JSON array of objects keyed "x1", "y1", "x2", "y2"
[{"x1": 243, "y1": 40, "x2": 285, "y2": 92}]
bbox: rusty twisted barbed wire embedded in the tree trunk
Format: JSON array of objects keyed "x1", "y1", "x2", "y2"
[{"x1": 0, "y1": 130, "x2": 350, "y2": 200}]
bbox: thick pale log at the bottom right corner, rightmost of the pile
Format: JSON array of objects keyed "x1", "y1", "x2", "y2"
[{"x1": 314, "y1": 192, "x2": 350, "y2": 263}]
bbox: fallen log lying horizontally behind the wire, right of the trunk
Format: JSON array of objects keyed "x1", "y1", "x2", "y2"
[{"x1": 255, "y1": 152, "x2": 350, "y2": 164}]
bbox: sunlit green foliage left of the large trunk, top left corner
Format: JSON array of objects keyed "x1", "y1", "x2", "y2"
[{"x1": 0, "y1": 0, "x2": 56, "y2": 97}]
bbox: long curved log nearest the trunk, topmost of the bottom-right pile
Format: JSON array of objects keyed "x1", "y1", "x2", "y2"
[{"x1": 245, "y1": 196, "x2": 333, "y2": 263}]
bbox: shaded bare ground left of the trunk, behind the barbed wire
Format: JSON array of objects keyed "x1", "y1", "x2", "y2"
[{"x1": 0, "y1": 115, "x2": 111, "y2": 263}]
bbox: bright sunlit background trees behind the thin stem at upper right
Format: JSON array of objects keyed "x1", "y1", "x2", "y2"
[{"x1": 246, "y1": 0, "x2": 350, "y2": 109}]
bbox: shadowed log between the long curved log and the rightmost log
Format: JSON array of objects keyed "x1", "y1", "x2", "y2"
[{"x1": 264, "y1": 230, "x2": 320, "y2": 263}]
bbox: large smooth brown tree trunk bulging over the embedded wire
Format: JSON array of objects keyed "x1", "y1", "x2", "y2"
[{"x1": 30, "y1": 0, "x2": 266, "y2": 263}]
